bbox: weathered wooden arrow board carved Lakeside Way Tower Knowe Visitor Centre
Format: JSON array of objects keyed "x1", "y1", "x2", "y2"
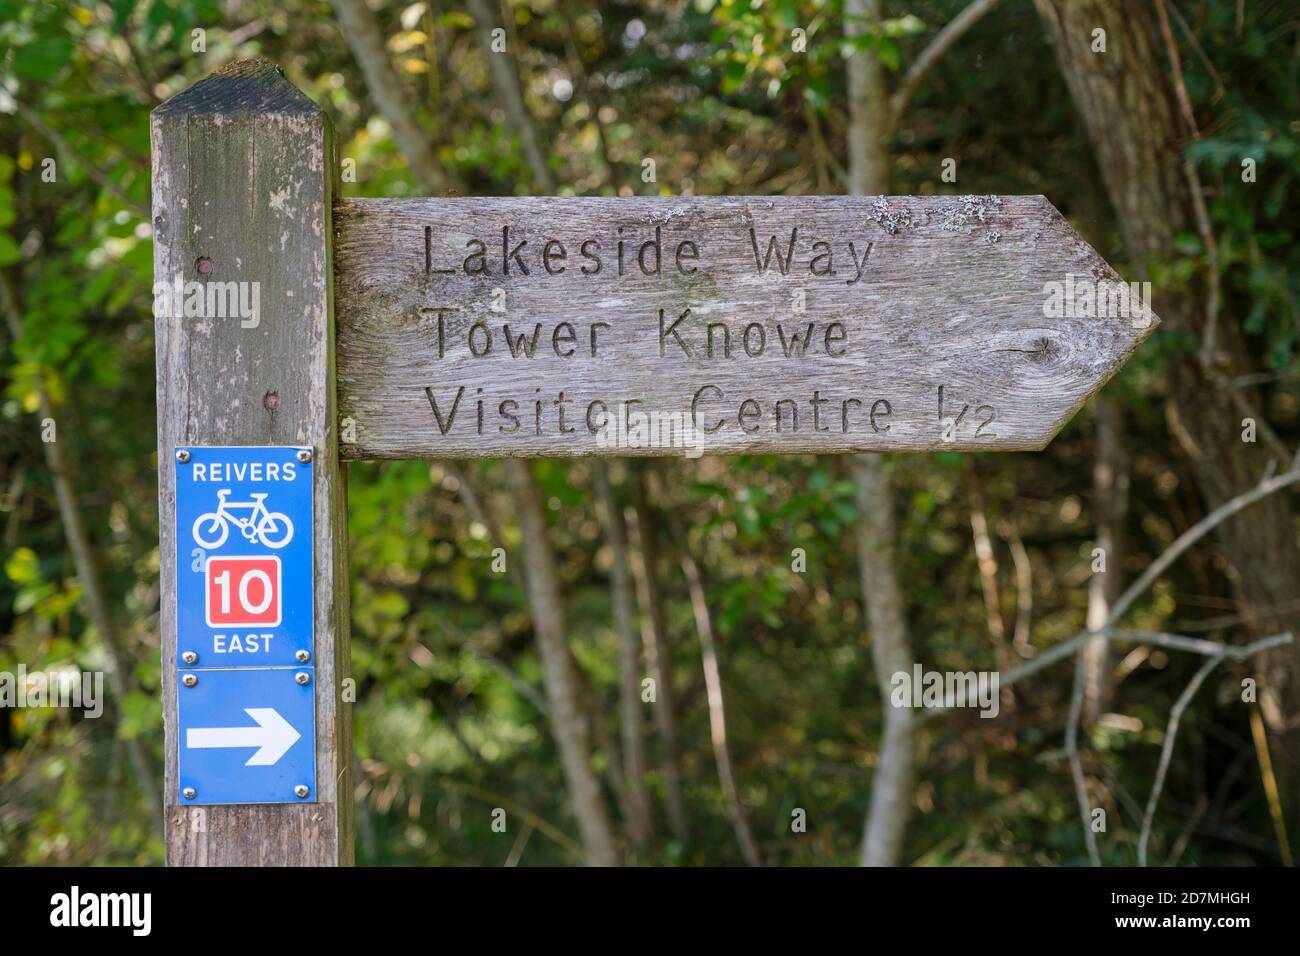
[{"x1": 334, "y1": 196, "x2": 1157, "y2": 458}]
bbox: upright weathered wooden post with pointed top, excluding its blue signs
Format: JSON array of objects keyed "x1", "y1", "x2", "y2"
[{"x1": 151, "y1": 60, "x2": 354, "y2": 866}]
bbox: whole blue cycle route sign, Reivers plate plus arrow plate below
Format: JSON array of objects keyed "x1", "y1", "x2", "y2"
[{"x1": 176, "y1": 446, "x2": 316, "y2": 805}]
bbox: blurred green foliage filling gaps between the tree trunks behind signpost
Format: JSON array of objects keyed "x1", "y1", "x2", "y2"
[{"x1": 0, "y1": 0, "x2": 1300, "y2": 865}]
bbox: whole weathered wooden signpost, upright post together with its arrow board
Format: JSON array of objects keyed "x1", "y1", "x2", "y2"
[{"x1": 152, "y1": 61, "x2": 1157, "y2": 865}]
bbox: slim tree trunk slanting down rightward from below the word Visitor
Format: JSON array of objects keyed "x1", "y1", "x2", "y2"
[{"x1": 504, "y1": 458, "x2": 619, "y2": 866}]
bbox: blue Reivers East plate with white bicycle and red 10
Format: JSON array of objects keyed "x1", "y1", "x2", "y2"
[{"x1": 176, "y1": 446, "x2": 313, "y2": 667}]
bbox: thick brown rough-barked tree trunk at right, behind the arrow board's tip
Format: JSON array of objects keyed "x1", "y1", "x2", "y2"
[{"x1": 1035, "y1": 0, "x2": 1300, "y2": 832}]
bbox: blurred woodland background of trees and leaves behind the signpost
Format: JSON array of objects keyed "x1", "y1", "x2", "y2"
[{"x1": 0, "y1": 0, "x2": 1300, "y2": 865}]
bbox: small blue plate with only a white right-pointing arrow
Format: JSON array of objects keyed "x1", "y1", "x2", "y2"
[{"x1": 177, "y1": 667, "x2": 316, "y2": 805}]
